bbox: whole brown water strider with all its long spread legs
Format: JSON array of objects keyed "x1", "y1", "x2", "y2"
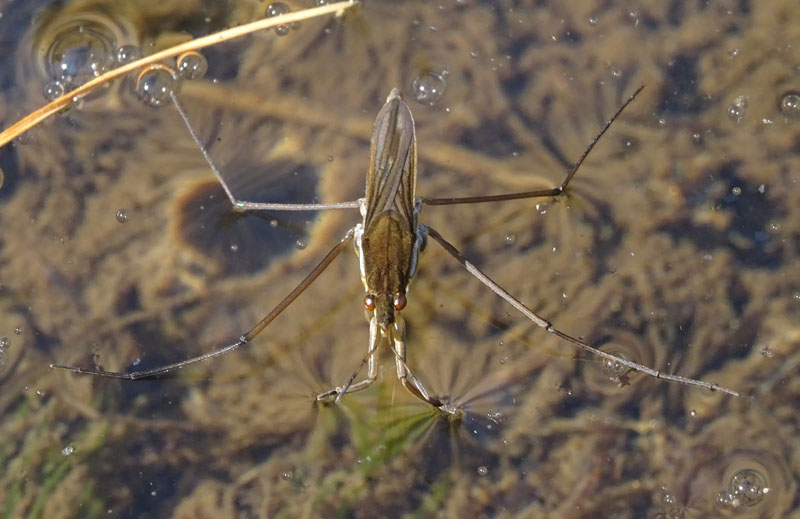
[{"x1": 51, "y1": 86, "x2": 739, "y2": 415}]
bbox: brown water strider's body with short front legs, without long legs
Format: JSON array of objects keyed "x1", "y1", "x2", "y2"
[{"x1": 317, "y1": 89, "x2": 440, "y2": 410}]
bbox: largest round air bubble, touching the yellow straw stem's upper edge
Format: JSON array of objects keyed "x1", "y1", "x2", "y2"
[{"x1": 45, "y1": 22, "x2": 116, "y2": 88}]
